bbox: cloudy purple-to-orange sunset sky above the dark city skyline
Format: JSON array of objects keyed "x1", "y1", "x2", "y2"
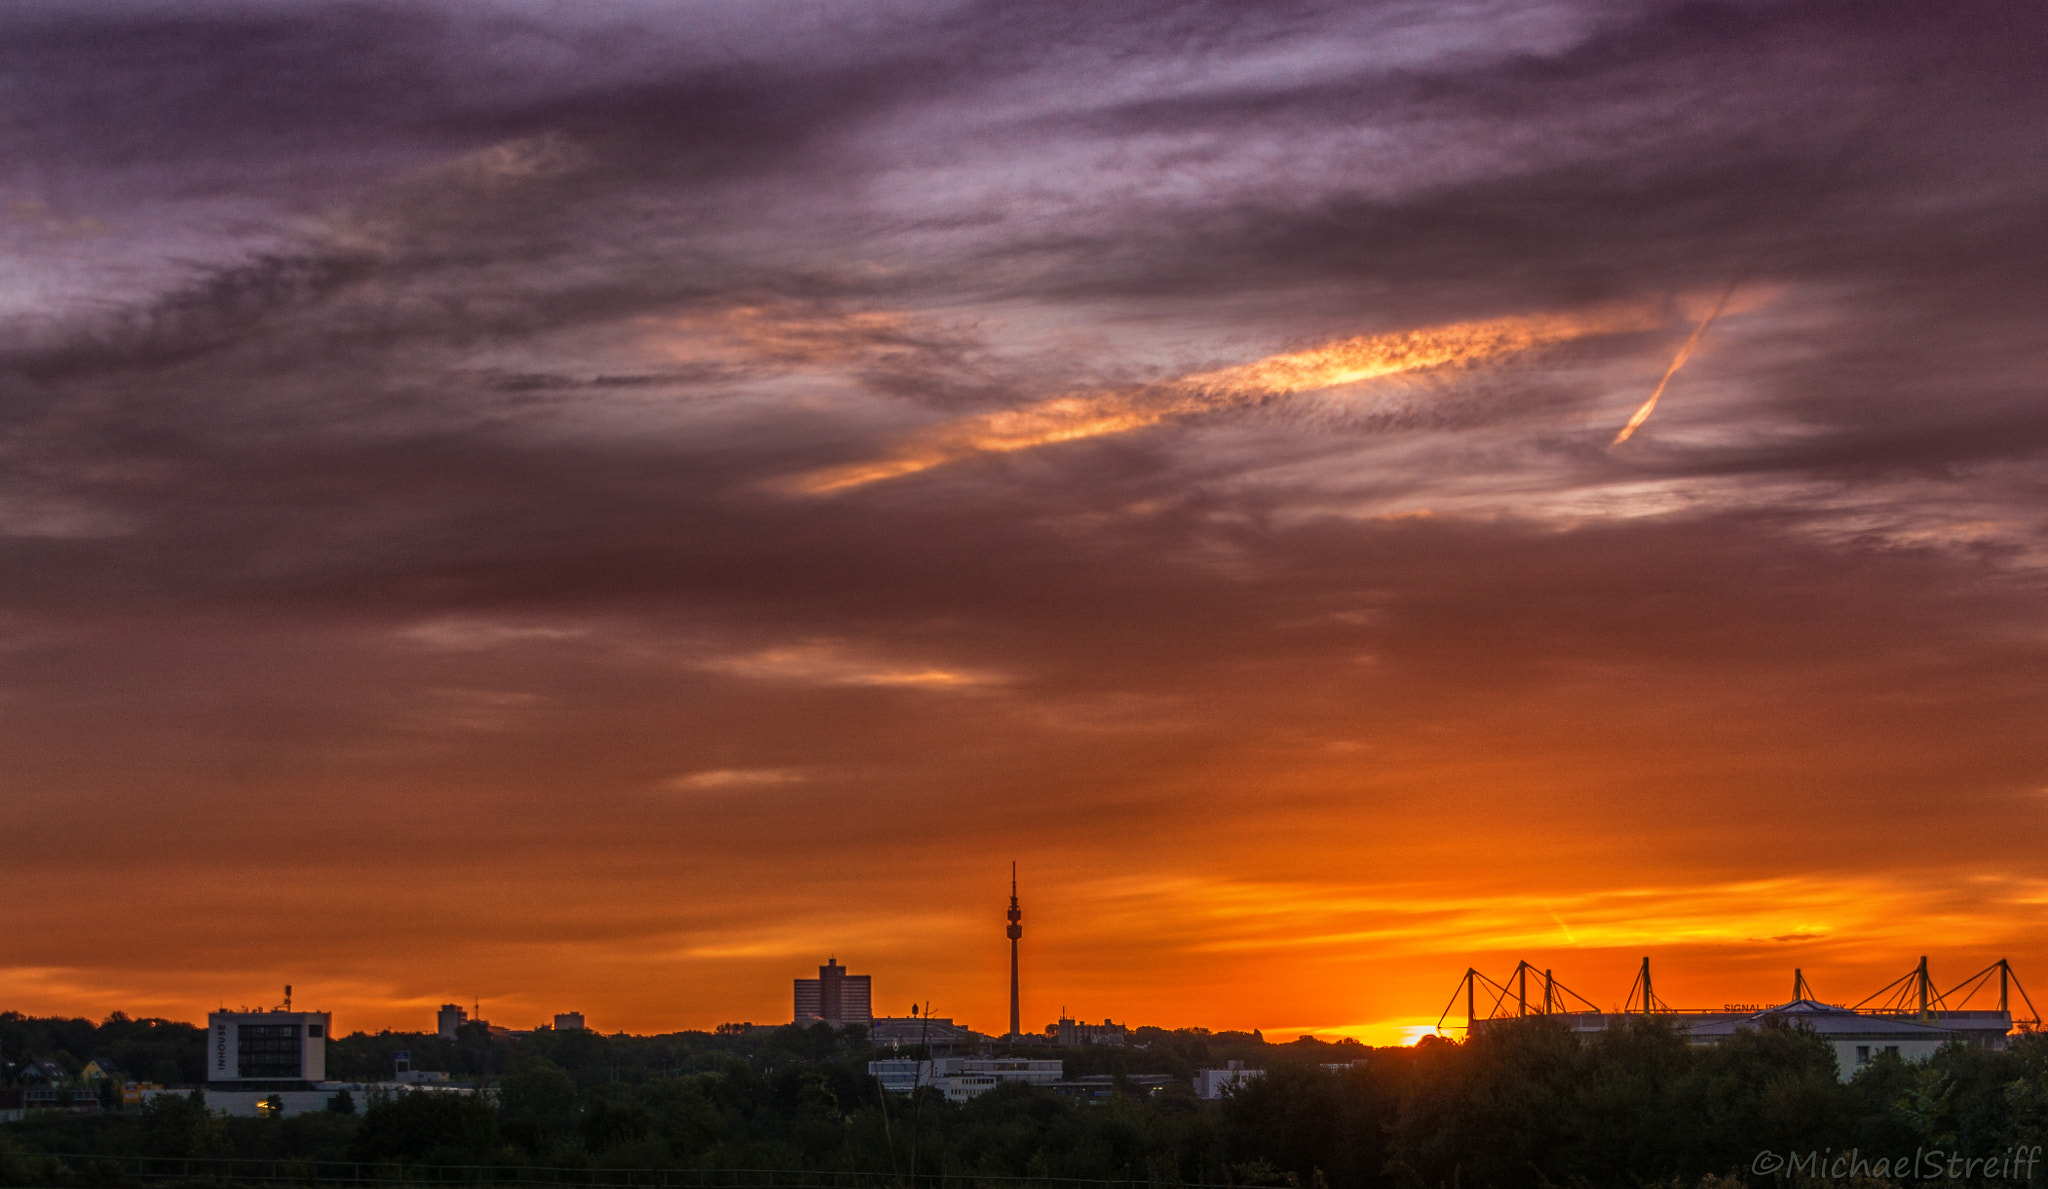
[{"x1": 0, "y1": 0, "x2": 2048, "y2": 1044}]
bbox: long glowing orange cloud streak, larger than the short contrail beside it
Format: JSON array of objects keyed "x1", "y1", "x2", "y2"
[{"x1": 795, "y1": 307, "x2": 1646, "y2": 493}]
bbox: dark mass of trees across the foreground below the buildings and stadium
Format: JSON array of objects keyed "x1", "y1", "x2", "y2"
[{"x1": 0, "y1": 1019, "x2": 2048, "y2": 1189}]
